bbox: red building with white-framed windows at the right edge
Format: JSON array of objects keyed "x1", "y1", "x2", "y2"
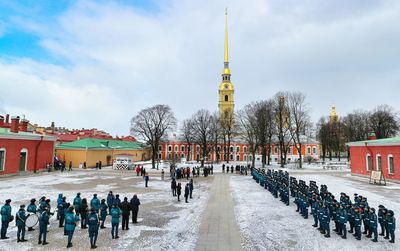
[{"x1": 347, "y1": 137, "x2": 400, "y2": 180}]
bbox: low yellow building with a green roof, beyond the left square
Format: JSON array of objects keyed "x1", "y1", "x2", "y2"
[{"x1": 56, "y1": 138, "x2": 151, "y2": 168}]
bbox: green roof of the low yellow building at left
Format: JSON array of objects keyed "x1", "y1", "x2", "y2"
[{"x1": 56, "y1": 138, "x2": 146, "y2": 150}]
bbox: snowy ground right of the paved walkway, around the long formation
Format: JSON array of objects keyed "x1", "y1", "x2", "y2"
[{"x1": 231, "y1": 172, "x2": 400, "y2": 250}]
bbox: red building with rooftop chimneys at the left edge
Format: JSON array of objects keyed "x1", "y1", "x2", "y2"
[{"x1": 0, "y1": 115, "x2": 56, "y2": 175}]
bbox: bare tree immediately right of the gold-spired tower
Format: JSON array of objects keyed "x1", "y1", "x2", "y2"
[{"x1": 237, "y1": 103, "x2": 260, "y2": 167}]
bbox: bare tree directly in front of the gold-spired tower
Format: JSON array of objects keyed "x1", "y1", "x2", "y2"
[{"x1": 220, "y1": 110, "x2": 236, "y2": 163}]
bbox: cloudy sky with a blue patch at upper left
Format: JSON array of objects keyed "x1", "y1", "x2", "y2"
[{"x1": 0, "y1": 0, "x2": 400, "y2": 135}]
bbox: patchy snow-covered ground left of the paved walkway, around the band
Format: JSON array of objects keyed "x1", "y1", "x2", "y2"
[{"x1": 0, "y1": 168, "x2": 212, "y2": 250}]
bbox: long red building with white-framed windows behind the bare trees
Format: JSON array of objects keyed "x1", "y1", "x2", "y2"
[{"x1": 158, "y1": 137, "x2": 320, "y2": 163}]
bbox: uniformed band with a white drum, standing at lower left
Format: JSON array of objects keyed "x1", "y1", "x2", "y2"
[{"x1": 0, "y1": 191, "x2": 140, "y2": 249}]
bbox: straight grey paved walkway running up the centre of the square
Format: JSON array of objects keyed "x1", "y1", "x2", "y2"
[{"x1": 196, "y1": 175, "x2": 242, "y2": 251}]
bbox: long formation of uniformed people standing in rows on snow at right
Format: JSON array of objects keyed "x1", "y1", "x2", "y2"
[{"x1": 252, "y1": 168, "x2": 396, "y2": 243}]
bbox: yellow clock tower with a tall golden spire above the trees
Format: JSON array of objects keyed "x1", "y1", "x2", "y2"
[{"x1": 218, "y1": 9, "x2": 235, "y2": 121}]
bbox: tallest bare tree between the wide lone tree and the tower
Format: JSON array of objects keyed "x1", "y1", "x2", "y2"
[{"x1": 191, "y1": 109, "x2": 213, "y2": 167}]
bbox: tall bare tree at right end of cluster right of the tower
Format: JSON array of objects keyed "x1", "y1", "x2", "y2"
[{"x1": 287, "y1": 92, "x2": 310, "y2": 168}]
